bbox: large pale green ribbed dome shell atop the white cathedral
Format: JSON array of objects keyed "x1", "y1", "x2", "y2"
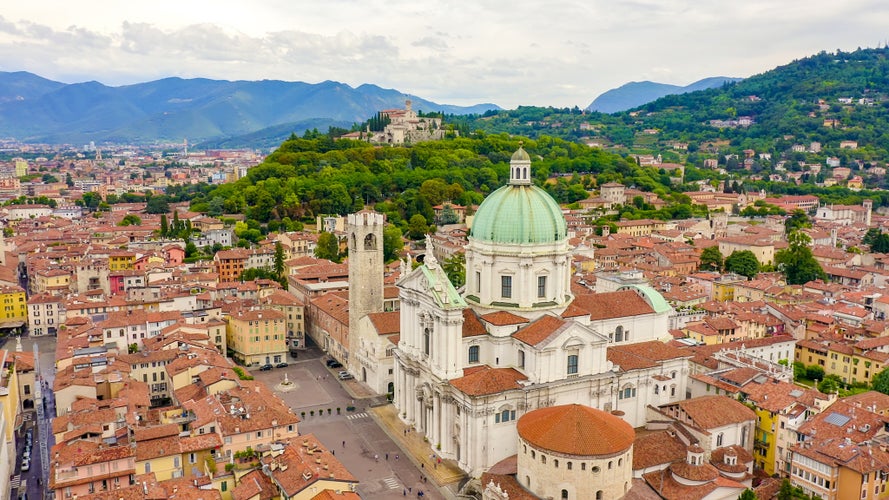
[{"x1": 470, "y1": 185, "x2": 568, "y2": 244}]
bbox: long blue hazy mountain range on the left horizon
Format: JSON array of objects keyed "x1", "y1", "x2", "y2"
[{"x1": 0, "y1": 72, "x2": 500, "y2": 144}]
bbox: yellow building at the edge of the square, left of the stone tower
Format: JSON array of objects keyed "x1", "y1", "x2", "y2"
[{"x1": 226, "y1": 309, "x2": 287, "y2": 366}]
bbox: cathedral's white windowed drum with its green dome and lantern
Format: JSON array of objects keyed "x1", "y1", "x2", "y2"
[{"x1": 464, "y1": 147, "x2": 573, "y2": 319}]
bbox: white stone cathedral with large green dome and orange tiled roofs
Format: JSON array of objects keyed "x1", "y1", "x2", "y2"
[{"x1": 394, "y1": 148, "x2": 688, "y2": 477}]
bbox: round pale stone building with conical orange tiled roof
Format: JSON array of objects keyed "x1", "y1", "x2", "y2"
[{"x1": 516, "y1": 404, "x2": 636, "y2": 500}]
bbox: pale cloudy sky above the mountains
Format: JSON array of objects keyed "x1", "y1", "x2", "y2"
[{"x1": 0, "y1": 0, "x2": 889, "y2": 108}]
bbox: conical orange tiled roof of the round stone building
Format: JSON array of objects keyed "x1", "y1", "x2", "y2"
[{"x1": 516, "y1": 404, "x2": 636, "y2": 456}]
